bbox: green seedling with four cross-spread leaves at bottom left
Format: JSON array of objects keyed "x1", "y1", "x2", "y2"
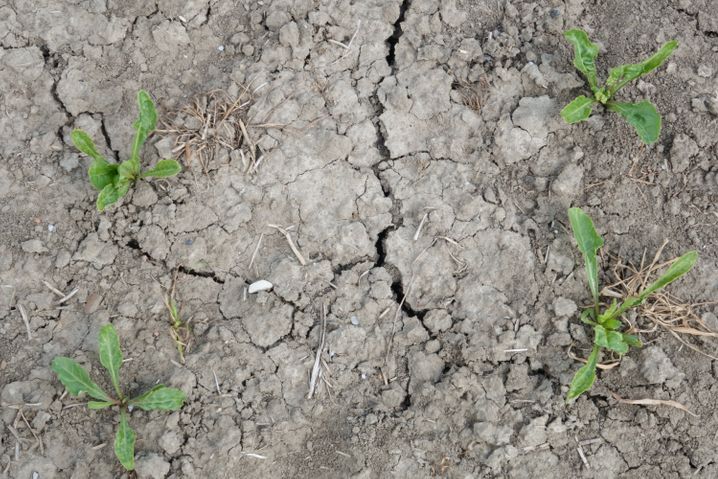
[{"x1": 52, "y1": 324, "x2": 185, "y2": 471}]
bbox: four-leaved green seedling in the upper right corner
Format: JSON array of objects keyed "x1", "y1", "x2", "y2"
[{"x1": 561, "y1": 28, "x2": 678, "y2": 145}]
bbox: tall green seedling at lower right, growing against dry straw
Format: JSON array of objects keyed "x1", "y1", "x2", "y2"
[{"x1": 566, "y1": 208, "x2": 698, "y2": 402}]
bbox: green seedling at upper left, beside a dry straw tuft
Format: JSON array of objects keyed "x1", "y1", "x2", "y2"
[{"x1": 70, "y1": 90, "x2": 182, "y2": 211}]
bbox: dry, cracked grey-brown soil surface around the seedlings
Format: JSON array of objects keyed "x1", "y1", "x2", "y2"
[{"x1": 0, "y1": 0, "x2": 718, "y2": 479}]
